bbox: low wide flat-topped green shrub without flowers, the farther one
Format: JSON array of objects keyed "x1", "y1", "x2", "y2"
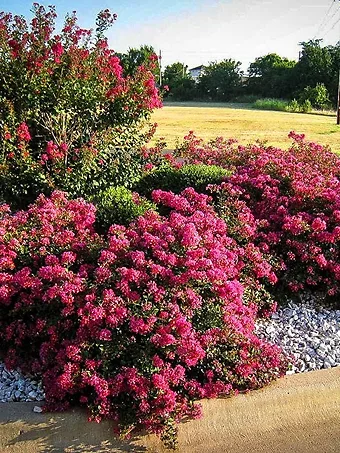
[{"x1": 134, "y1": 164, "x2": 230, "y2": 197}]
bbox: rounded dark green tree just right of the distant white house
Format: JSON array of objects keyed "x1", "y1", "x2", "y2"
[{"x1": 198, "y1": 58, "x2": 243, "y2": 101}]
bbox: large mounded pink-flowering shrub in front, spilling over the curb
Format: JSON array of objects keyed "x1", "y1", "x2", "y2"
[{"x1": 0, "y1": 188, "x2": 287, "y2": 446}]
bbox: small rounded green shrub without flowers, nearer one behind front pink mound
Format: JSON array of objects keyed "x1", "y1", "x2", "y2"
[{"x1": 93, "y1": 186, "x2": 157, "y2": 232}]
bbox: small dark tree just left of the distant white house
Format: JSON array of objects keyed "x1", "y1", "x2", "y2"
[{"x1": 163, "y1": 62, "x2": 196, "y2": 101}]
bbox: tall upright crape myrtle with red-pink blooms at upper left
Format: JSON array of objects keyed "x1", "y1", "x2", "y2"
[{"x1": 0, "y1": 3, "x2": 161, "y2": 208}]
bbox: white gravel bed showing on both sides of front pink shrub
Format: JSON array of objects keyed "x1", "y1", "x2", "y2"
[{"x1": 0, "y1": 295, "x2": 340, "y2": 403}]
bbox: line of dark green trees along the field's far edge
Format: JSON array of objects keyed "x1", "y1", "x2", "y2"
[{"x1": 121, "y1": 39, "x2": 340, "y2": 109}]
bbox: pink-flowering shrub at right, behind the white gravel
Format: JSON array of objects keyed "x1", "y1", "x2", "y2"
[{"x1": 176, "y1": 132, "x2": 340, "y2": 296}]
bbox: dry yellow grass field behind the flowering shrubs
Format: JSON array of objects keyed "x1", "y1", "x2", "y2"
[{"x1": 152, "y1": 102, "x2": 340, "y2": 154}]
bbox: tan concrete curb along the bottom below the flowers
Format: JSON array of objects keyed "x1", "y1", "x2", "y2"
[{"x1": 0, "y1": 367, "x2": 340, "y2": 453}]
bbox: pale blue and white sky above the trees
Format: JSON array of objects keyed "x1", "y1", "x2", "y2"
[{"x1": 0, "y1": 0, "x2": 340, "y2": 72}]
